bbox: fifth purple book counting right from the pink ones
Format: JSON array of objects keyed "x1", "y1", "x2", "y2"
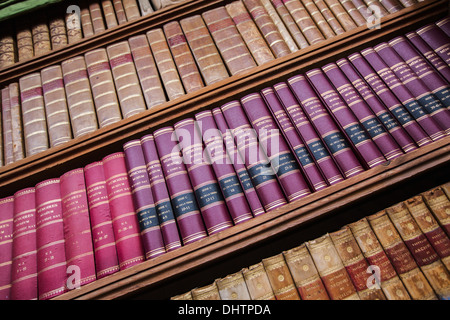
[{"x1": 195, "y1": 110, "x2": 253, "y2": 224}]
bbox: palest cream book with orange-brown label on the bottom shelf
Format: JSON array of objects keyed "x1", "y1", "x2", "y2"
[{"x1": 306, "y1": 234, "x2": 360, "y2": 300}]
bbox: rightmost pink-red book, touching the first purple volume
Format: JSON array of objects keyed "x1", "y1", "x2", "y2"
[{"x1": 103, "y1": 152, "x2": 145, "y2": 270}]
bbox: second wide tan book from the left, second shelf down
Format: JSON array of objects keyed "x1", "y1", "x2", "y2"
[{"x1": 41, "y1": 65, "x2": 72, "y2": 147}]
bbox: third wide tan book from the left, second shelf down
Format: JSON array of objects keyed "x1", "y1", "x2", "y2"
[{"x1": 61, "y1": 56, "x2": 98, "y2": 138}]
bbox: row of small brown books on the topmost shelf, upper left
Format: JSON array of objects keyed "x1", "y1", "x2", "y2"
[{"x1": 0, "y1": 0, "x2": 185, "y2": 69}]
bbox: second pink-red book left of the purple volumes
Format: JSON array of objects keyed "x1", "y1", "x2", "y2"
[{"x1": 84, "y1": 161, "x2": 119, "y2": 279}]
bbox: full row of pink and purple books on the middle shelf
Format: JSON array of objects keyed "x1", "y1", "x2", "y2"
[{"x1": 0, "y1": 15, "x2": 450, "y2": 299}]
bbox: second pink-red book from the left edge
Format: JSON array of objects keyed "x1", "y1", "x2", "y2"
[{"x1": 11, "y1": 187, "x2": 38, "y2": 300}]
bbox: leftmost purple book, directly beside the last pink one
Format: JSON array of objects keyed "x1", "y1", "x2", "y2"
[{"x1": 123, "y1": 139, "x2": 166, "y2": 260}]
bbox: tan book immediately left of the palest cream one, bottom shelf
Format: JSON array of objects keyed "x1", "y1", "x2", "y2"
[{"x1": 283, "y1": 244, "x2": 330, "y2": 300}]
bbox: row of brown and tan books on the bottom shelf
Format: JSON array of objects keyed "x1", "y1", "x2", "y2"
[{"x1": 171, "y1": 183, "x2": 450, "y2": 300}]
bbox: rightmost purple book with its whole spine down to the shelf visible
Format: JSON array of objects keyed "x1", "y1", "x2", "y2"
[{"x1": 361, "y1": 48, "x2": 445, "y2": 140}]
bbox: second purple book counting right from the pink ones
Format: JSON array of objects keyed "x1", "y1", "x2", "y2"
[{"x1": 141, "y1": 134, "x2": 181, "y2": 252}]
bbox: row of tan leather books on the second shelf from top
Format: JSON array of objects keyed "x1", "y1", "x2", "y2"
[{"x1": 0, "y1": 0, "x2": 426, "y2": 165}]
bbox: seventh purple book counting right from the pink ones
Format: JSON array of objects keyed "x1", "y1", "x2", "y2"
[{"x1": 221, "y1": 101, "x2": 287, "y2": 212}]
